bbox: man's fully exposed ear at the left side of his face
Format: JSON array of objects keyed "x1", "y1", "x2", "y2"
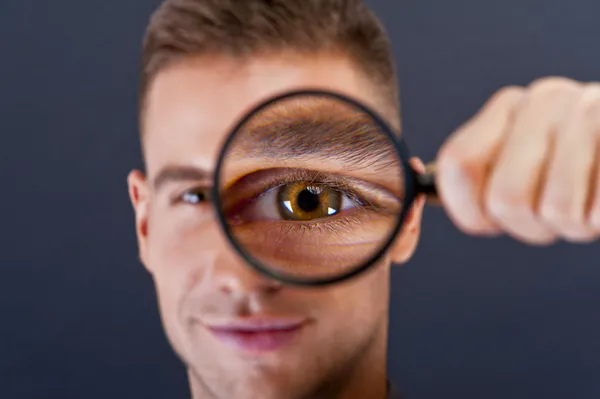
[{"x1": 127, "y1": 170, "x2": 149, "y2": 269}]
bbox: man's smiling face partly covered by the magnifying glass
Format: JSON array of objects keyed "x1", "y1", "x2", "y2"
[{"x1": 129, "y1": 55, "x2": 420, "y2": 399}]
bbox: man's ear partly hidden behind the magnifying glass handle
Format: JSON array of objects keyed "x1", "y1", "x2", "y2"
[{"x1": 390, "y1": 158, "x2": 426, "y2": 264}]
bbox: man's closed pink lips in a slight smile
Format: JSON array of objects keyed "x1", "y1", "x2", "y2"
[{"x1": 208, "y1": 317, "x2": 305, "y2": 352}]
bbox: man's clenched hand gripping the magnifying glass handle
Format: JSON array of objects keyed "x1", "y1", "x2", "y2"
[{"x1": 437, "y1": 77, "x2": 600, "y2": 245}]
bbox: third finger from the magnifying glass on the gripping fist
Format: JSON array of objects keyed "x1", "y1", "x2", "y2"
[{"x1": 539, "y1": 86, "x2": 600, "y2": 242}]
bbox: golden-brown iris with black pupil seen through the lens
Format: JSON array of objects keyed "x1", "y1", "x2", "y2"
[{"x1": 277, "y1": 182, "x2": 344, "y2": 221}]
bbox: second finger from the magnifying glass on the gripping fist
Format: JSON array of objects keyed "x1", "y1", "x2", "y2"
[{"x1": 485, "y1": 80, "x2": 575, "y2": 245}]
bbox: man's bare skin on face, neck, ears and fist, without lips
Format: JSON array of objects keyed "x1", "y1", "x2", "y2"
[{"x1": 128, "y1": 49, "x2": 600, "y2": 399}]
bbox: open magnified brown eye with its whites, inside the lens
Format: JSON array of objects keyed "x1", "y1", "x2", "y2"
[{"x1": 250, "y1": 182, "x2": 358, "y2": 221}]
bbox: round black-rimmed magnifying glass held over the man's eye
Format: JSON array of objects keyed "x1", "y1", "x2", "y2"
[{"x1": 212, "y1": 91, "x2": 436, "y2": 286}]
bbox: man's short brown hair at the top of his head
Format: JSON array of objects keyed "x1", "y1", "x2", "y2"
[{"x1": 140, "y1": 0, "x2": 399, "y2": 126}]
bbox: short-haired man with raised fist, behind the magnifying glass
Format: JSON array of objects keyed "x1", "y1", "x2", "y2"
[{"x1": 128, "y1": 0, "x2": 600, "y2": 399}]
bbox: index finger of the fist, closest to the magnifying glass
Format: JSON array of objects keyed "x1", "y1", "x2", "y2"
[{"x1": 436, "y1": 87, "x2": 524, "y2": 235}]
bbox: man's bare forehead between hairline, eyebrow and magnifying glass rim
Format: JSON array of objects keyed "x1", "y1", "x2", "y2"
[{"x1": 144, "y1": 55, "x2": 384, "y2": 180}]
